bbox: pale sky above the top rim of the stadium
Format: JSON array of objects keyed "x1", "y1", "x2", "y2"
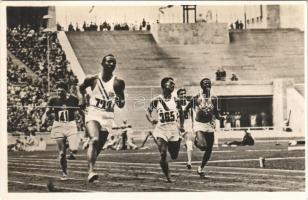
[{"x1": 56, "y1": 2, "x2": 304, "y2": 30}]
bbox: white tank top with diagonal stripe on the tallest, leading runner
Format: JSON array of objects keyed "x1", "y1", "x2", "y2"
[{"x1": 89, "y1": 73, "x2": 115, "y2": 112}]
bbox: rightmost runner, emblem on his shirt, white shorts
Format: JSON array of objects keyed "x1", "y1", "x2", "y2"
[{"x1": 184, "y1": 78, "x2": 219, "y2": 178}]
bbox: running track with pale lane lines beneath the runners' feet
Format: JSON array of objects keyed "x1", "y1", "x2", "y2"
[{"x1": 7, "y1": 145, "x2": 306, "y2": 192}]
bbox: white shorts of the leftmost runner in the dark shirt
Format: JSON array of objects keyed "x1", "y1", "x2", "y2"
[{"x1": 50, "y1": 121, "x2": 80, "y2": 150}]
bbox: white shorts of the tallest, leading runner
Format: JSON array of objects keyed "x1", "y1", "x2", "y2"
[{"x1": 85, "y1": 107, "x2": 114, "y2": 133}]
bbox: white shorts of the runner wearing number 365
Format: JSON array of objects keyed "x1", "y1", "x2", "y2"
[{"x1": 153, "y1": 124, "x2": 180, "y2": 142}]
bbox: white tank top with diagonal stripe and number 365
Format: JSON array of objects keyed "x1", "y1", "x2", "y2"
[{"x1": 157, "y1": 95, "x2": 179, "y2": 126}]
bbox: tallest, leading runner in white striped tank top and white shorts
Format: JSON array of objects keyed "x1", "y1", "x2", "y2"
[{"x1": 79, "y1": 54, "x2": 125, "y2": 182}]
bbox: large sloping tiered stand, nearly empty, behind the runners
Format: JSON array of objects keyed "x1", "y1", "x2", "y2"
[{"x1": 67, "y1": 29, "x2": 304, "y2": 127}]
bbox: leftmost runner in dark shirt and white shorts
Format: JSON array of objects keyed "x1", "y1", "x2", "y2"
[{"x1": 42, "y1": 82, "x2": 83, "y2": 180}]
